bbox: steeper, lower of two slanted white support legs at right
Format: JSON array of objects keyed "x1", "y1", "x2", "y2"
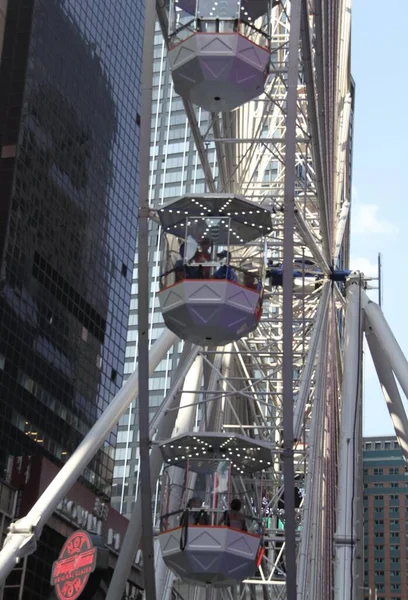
[{"x1": 365, "y1": 323, "x2": 408, "y2": 467}]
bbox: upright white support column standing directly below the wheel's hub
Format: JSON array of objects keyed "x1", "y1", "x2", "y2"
[{"x1": 334, "y1": 274, "x2": 362, "y2": 600}]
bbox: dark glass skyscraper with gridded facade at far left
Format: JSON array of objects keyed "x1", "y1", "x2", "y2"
[{"x1": 0, "y1": 0, "x2": 144, "y2": 600}]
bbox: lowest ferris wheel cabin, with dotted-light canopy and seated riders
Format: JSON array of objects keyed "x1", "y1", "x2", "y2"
[{"x1": 159, "y1": 432, "x2": 271, "y2": 587}]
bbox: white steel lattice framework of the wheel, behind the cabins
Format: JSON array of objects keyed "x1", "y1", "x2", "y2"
[{"x1": 147, "y1": 1, "x2": 351, "y2": 598}]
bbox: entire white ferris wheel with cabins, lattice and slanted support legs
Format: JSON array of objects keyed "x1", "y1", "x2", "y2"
[{"x1": 0, "y1": 0, "x2": 408, "y2": 600}]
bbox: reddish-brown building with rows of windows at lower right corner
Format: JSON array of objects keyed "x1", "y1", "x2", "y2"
[{"x1": 363, "y1": 437, "x2": 408, "y2": 600}]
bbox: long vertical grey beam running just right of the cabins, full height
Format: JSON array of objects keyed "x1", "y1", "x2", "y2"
[{"x1": 282, "y1": 0, "x2": 301, "y2": 600}]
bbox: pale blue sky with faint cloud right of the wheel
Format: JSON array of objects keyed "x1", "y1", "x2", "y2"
[{"x1": 351, "y1": 0, "x2": 408, "y2": 436}]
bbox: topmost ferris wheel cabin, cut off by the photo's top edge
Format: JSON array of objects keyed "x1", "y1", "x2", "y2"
[{"x1": 168, "y1": 0, "x2": 271, "y2": 112}]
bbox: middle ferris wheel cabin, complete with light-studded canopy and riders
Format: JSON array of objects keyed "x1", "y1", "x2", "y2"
[{"x1": 158, "y1": 194, "x2": 272, "y2": 346}]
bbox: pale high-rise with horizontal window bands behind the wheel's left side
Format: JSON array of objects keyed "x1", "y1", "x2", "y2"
[{"x1": 112, "y1": 29, "x2": 216, "y2": 516}]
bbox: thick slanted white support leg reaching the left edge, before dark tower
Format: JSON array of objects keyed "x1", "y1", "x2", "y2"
[{"x1": 0, "y1": 330, "x2": 178, "y2": 585}]
